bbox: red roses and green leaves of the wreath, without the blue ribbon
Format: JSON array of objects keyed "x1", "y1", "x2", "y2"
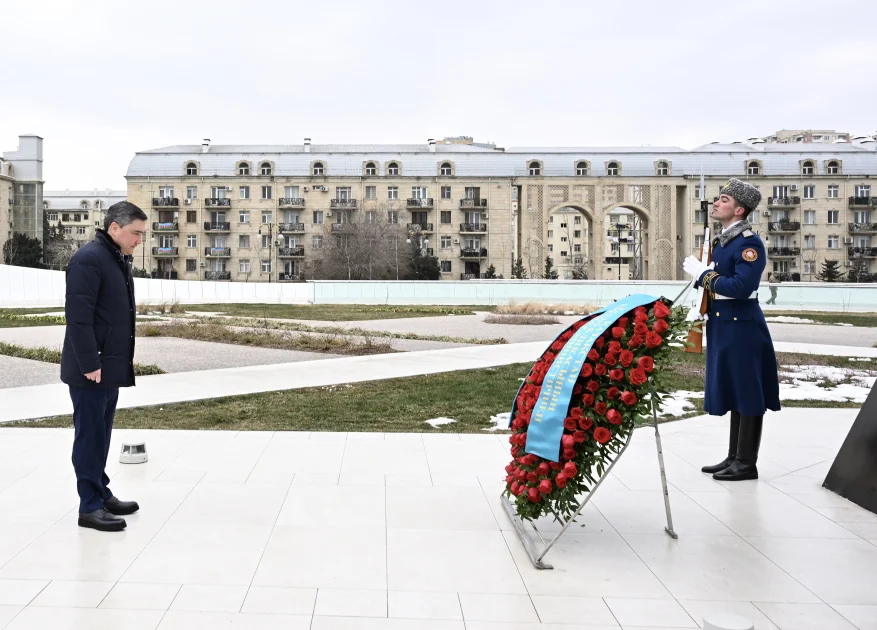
[{"x1": 505, "y1": 298, "x2": 686, "y2": 519}]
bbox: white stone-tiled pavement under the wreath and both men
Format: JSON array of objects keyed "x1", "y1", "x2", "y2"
[{"x1": 0, "y1": 410, "x2": 877, "y2": 630}]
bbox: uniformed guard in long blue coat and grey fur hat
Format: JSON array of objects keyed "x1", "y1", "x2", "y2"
[{"x1": 683, "y1": 179, "x2": 780, "y2": 481}]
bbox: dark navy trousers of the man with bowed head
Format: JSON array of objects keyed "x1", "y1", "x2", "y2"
[{"x1": 70, "y1": 386, "x2": 119, "y2": 514}]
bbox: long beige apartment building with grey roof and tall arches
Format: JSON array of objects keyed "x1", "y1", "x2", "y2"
[{"x1": 126, "y1": 137, "x2": 877, "y2": 281}]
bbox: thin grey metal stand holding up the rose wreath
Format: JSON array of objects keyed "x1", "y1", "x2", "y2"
[{"x1": 500, "y1": 281, "x2": 694, "y2": 569}]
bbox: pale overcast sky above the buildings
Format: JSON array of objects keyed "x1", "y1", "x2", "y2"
[{"x1": 0, "y1": 0, "x2": 877, "y2": 190}]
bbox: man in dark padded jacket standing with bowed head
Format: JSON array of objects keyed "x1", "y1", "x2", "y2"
[{"x1": 61, "y1": 201, "x2": 147, "y2": 531}]
